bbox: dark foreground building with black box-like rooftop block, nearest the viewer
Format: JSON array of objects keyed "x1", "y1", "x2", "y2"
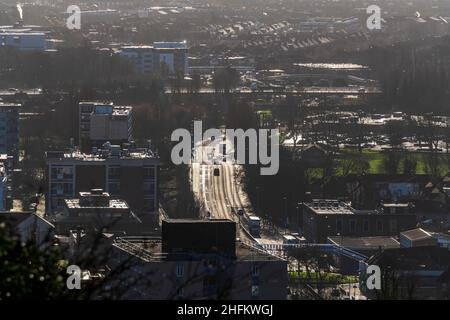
[{"x1": 108, "y1": 220, "x2": 287, "y2": 300}]
